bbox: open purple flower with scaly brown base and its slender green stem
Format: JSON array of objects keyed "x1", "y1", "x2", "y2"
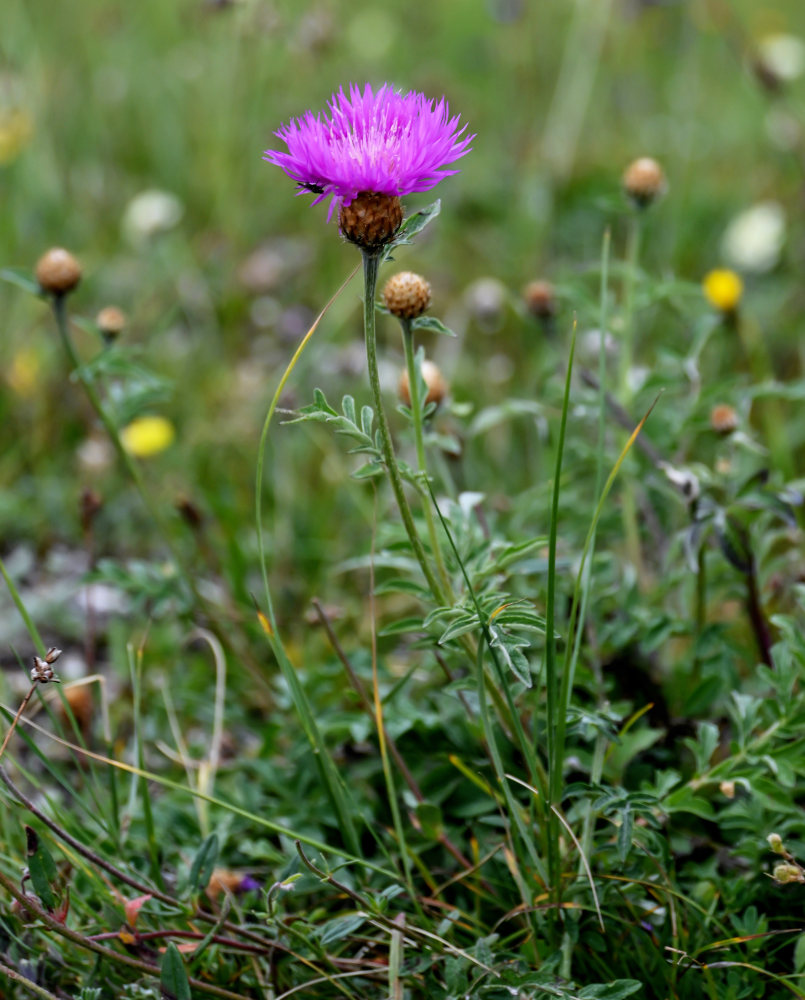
[{"x1": 264, "y1": 84, "x2": 474, "y2": 604}]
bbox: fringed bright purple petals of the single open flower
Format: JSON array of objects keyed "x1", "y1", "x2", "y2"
[{"x1": 263, "y1": 83, "x2": 475, "y2": 215}]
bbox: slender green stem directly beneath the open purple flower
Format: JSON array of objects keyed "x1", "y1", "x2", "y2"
[{"x1": 363, "y1": 251, "x2": 447, "y2": 605}]
